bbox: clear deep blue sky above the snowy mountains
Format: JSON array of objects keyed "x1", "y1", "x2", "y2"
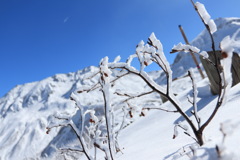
[{"x1": 0, "y1": 0, "x2": 240, "y2": 97}]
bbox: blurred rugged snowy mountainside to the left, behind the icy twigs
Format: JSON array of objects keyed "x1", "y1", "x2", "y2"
[{"x1": 0, "y1": 67, "x2": 150, "y2": 159}]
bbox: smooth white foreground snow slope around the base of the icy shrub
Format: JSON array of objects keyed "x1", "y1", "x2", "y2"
[{"x1": 116, "y1": 80, "x2": 240, "y2": 160}]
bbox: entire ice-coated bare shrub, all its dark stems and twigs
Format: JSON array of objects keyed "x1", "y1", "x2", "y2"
[{"x1": 48, "y1": 1, "x2": 238, "y2": 160}]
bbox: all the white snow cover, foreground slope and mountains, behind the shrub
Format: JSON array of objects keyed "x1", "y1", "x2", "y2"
[{"x1": 0, "y1": 18, "x2": 240, "y2": 160}]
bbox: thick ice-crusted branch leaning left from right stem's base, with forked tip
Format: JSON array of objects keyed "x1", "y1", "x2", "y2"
[{"x1": 108, "y1": 33, "x2": 203, "y2": 145}]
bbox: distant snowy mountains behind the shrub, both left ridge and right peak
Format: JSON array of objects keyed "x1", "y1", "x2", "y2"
[{"x1": 0, "y1": 18, "x2": 240, "y2": 159}]
